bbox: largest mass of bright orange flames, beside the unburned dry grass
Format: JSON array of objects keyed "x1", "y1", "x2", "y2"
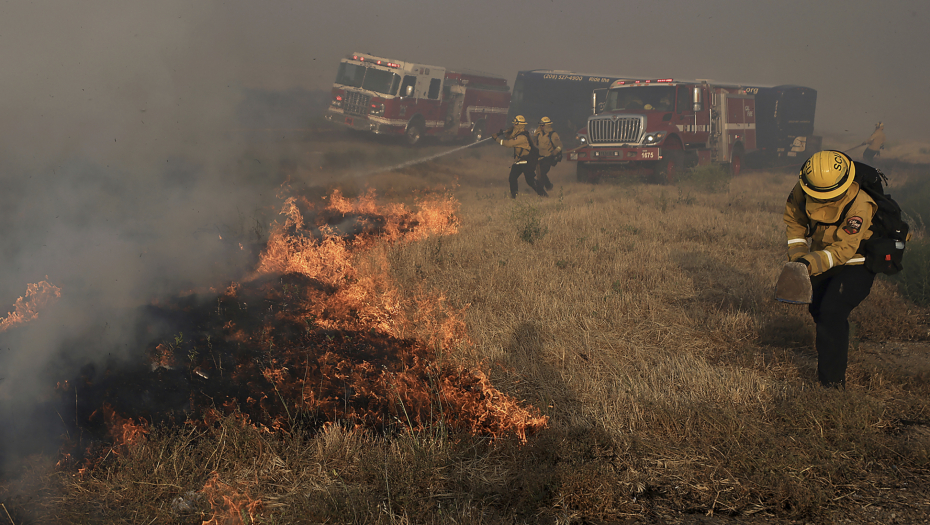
[{"x1": 205, "y1": 191, "x2": 547, "y2": 441}]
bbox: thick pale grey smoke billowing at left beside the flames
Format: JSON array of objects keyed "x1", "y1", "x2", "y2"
[{"x1": 0, "y1": 1, "x2": 294, "y2": 462}]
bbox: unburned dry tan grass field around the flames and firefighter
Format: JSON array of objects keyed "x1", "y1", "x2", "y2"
[{"x1": 0, "y1": 139, "x2": 930, "y2": 525}]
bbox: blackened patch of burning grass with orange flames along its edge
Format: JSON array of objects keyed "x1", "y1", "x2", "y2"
[{"x1": 21, "y1": 191, "x2": 547, "y2": 524}]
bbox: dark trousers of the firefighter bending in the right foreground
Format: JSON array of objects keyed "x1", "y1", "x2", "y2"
[{"x1": 809, "y1": 265, "x2": 875, "y2": 387}]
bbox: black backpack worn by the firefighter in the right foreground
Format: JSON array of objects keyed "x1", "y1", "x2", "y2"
[{"x1": 840, "y1": 162, "x2": 910, "y2": 275}]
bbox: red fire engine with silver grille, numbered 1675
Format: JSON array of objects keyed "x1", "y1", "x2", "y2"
[{"x1": 568, "y1": 78, "x2": 759, "y2": 182}]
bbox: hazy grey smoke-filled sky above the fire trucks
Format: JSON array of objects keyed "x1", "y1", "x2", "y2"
[{"x1": 0, "y1": 0, "x2": 930, "y2": 156}]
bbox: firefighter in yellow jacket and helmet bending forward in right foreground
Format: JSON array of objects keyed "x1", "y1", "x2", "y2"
[{"x1": 785, "y1": 151, "x2": 878, "y2": 387}]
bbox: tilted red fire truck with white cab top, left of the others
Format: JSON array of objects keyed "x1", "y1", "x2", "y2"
[{"x1": 326, "y1": 53, "x2": 510, "y2": 145}]
